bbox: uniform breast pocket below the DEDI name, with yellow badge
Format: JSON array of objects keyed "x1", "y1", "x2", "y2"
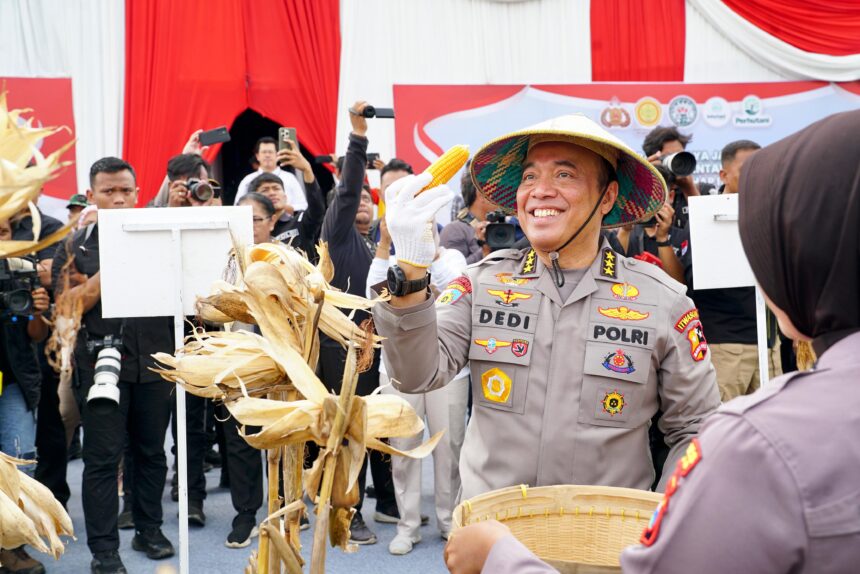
[{"x1": 469, "y1": 329, "x2": 533, "y2": 414}]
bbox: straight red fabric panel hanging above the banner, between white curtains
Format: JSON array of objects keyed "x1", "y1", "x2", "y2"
[{"x1": 591, "y1": 0, "x2": 686, "y2": 82}]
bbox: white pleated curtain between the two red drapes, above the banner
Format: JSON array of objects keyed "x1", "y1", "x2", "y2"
[{"x1": 336, "y1": 0, "x2": 591, "y2": 160}]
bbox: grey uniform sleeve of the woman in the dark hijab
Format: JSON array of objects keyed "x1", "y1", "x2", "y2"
[{"x1": 621, "y1": 413, "x2": 806, "y2": 574}]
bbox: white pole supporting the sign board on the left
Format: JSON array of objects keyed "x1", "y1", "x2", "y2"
[{"x1": 171, "y1": 227, "x2": 188, "y2": 574}]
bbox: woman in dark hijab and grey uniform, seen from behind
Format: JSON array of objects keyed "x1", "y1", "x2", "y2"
[{"x1": 446, "y1": 111, "x2": 860, "y2": 574}]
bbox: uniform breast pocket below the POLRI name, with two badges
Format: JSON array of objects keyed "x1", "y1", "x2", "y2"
[{"x1": 578, "y1": 341, "x2": 651, "y2": 428}]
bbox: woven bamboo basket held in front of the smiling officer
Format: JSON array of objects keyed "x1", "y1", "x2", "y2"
[{"x1": 453, "y1": 485, "x2": 663, "y2": 574}]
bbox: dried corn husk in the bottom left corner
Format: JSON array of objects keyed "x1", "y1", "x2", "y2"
[{"x1": 0, "y1": 452, "x2": 74, "y2": 559}]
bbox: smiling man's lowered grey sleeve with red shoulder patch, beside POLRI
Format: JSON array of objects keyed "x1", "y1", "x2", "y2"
[{"x1": 658, "y1": 293, "x2": 720, "y2": 491}]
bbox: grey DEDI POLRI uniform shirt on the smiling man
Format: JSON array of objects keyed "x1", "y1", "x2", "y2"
[{"x1": 374, "y1": 243, "x2": 720, "y2": 498}]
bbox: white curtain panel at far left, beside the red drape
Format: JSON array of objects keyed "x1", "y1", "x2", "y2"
[{"x1": 0, "y1": 0, "x2": 125, "y2": 221}]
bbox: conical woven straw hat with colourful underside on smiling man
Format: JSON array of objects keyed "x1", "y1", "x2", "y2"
[{"x1": 469, "y1": 114, "x2": 667, "y2": 228}]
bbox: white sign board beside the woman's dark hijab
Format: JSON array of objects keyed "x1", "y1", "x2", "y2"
[{"x1": 687, "y1": 193, "x2": 755, "y2": 290}]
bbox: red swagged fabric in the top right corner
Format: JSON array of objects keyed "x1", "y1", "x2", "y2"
[{"x1": 723, "y1": 0, "x2": 860, "y2": 56}]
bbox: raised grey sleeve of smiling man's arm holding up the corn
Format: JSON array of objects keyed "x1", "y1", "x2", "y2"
[{"x1": 373, "y1": 275, "x2": 472, "y2": 393}]
